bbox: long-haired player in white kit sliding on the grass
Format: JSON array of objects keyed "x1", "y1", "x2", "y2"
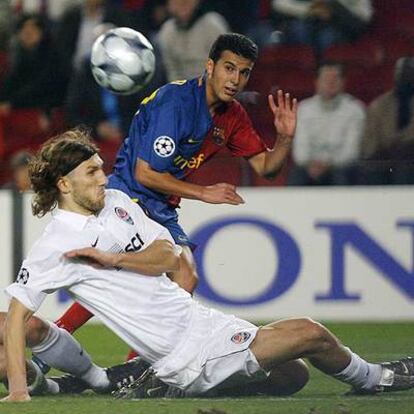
[{"x1": 4, "y1": 131, "x2": 414, "y2": 401}]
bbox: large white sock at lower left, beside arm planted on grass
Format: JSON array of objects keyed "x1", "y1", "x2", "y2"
[{"x1": 32, "y1": 324, "x2": 109, "y2": 388}]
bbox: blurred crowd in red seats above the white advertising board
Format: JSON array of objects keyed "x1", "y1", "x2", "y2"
[{"x1": 0, "y1": 0, "x2": 414, "y2": 191}]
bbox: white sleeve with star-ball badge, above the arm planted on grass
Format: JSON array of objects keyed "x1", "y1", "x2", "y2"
[{"x1": 5, "y1": 245, "x2": 69, "y2": 312}]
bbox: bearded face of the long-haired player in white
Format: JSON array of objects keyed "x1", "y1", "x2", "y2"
[{"x1": 66, "y1": 154, "x2": 107, "y2": 214}]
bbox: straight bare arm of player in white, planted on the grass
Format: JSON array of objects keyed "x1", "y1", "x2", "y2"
[{"x1": 1, "y1": 298, "x2": 33, "y2": 402}]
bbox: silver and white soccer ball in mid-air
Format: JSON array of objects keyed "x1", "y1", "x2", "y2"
[{"x1": 91, "y1": 27, "x2": 155, "y2": 95}]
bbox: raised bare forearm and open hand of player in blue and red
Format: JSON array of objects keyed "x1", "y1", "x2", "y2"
[{"x1": 249, "y1": 90, "x2": 297, "y2": 178}]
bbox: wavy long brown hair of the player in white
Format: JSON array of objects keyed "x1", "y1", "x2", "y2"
[{"x1": 29, "y1": 129, "x2": 98, "y2": 217}]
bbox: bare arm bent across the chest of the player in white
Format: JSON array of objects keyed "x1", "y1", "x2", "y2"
[{"x1": 65, "y1": 240, "x2": 181, "y2": 276}]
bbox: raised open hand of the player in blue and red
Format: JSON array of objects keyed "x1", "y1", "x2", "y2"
[{"x1": 269, "y1": 89, "x2": 298, "y2": 139}]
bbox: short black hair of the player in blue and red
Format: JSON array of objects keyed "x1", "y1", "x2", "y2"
[{"x1": 208, "y1": 33, "x2": 258, "y2": 63}]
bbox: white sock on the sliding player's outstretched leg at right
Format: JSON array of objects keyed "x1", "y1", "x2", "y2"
[{"x1": 333, "y1": 351, "x2": 382, "y2": 390}]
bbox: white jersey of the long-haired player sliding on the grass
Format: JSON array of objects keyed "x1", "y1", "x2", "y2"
[{"x1": 6, "y1": 190, "x2": 194, "y2": 363}]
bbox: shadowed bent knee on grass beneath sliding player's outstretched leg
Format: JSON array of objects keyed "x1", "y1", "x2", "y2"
[{"x1": 265, "y1": 359, "x2": 309, "y2": 396}]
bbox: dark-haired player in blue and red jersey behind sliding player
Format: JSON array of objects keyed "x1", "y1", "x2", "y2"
[{"x1": 52, "y1": 33, "x2": 297, "y2": 350}]
